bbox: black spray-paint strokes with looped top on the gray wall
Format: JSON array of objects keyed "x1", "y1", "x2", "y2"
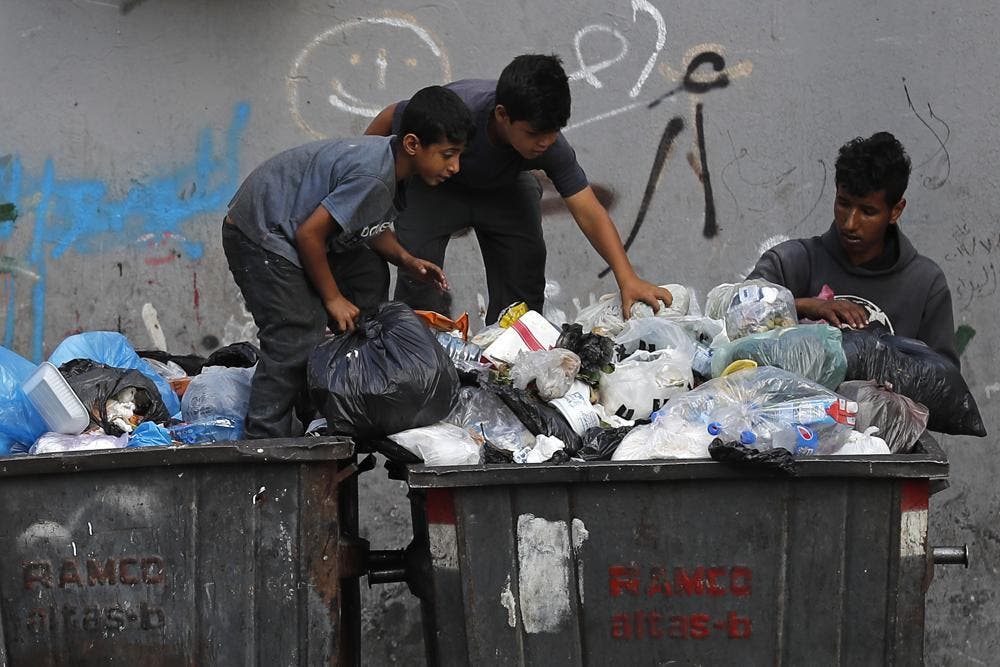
[{"x1": 598, "y1": 51, "x2": 729, "y2": 278}]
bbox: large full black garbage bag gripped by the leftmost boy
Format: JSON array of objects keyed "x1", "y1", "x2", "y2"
[{"x1": 308, "y1": 302, "x2": 459, "y2": 439}]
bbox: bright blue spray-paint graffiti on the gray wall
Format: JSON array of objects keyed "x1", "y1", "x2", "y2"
[{"x1": 0, "y1": 102, "x2": 250, "y2": 361}]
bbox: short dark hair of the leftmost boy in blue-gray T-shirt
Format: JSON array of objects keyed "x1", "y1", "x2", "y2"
[{"x1": 399, "y1": 86, "x2": 473, "y2": 146}]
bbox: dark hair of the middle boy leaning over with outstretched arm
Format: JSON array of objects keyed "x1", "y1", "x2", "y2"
[{"x1": 496, "y1": 54, "x2": 570, "y2": 132}]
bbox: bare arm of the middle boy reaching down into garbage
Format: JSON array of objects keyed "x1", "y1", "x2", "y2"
[{"x1": 565, "y1": 185, "x2": 674, "y2": 318}]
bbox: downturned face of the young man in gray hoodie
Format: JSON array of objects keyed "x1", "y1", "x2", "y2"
[{"x1": 833, "y1": 185, "x2": 906, "y2": 266}]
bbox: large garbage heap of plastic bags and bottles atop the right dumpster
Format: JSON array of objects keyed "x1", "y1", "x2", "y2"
[{"x1": 326, "y1": 280, "x2": 985, "y2": 469}]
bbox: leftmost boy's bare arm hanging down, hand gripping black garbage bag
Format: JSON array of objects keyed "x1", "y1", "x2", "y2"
[{"x1": 295, "y1": 206, "x2": 361, "y2": 331}]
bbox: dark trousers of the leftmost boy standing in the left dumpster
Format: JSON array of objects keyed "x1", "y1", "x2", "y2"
[{"x1": 222, "y1": 223, "x2": 389, "y2": 439}]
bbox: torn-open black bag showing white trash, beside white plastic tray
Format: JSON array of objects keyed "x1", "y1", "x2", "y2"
[{"x1": 59, "y1": 359, "x2": 170, "y2": 436}]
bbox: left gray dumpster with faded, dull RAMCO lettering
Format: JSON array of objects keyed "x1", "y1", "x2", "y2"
[{"x1": 0, "y1": 438, "x2": 359, "y2": 667}]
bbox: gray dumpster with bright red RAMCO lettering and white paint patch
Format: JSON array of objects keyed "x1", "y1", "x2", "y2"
[{"x1": 408, "y1": 437, "x2": 948, "y2": 665}]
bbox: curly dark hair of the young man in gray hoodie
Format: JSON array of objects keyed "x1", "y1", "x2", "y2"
[{"x1": 836, "y1": 132, "x2": 910, "y2": 208}]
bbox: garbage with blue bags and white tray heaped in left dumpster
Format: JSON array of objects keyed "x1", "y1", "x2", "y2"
[{"x1": 0, "y1": 331, "x2": 259, "y2": 456}]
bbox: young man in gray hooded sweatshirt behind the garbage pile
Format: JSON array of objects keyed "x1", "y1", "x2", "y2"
[{"x1": 748, "y1": 132, "x2": 959, "y2": 366}]
